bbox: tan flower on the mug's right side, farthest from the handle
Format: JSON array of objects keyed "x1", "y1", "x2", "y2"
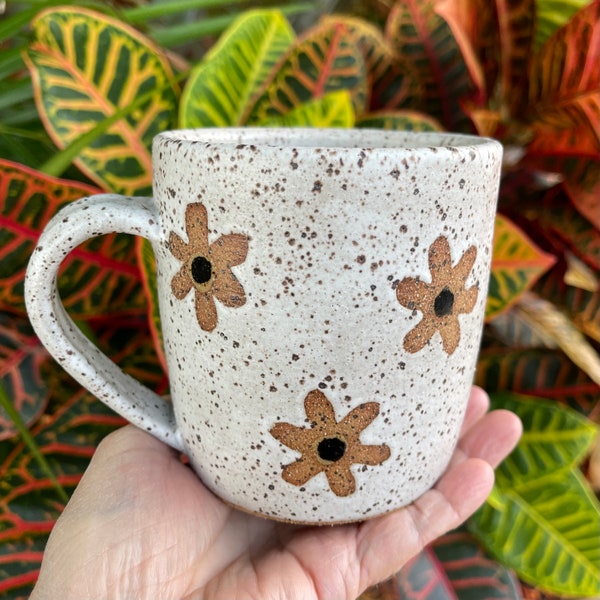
[{"x1": 396, "y1": 236, "x2": 479, "y2": 354}]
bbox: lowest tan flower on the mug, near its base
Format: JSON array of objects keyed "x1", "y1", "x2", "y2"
[{"x1": 270, "y1": 390, "x2": 390, "y2": 496}]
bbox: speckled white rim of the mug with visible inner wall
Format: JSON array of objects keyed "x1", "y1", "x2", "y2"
[{"x1": 154, "y1": 127, "x2": 502, "y2": 152}]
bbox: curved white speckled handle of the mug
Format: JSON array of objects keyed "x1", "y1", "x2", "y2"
[{"x1": 25, "y1": 194, "x2": 183, "y2": 451}]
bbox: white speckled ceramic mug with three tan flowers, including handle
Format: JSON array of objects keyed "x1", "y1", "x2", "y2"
[{"x1": 26, "y1": 129, "x2": 502, "y2": 523}]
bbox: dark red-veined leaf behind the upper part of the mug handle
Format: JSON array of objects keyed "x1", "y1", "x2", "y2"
[{"x1": 0, "y1": 159, "x2": 146, "y2": 318}]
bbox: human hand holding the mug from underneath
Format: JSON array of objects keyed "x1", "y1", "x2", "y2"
[{"x1": 31, "y1": 388, "x2": 521, "y2": 600}]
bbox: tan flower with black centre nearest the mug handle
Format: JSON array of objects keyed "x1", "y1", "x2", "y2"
[{"x1": 169, "y1": 202, "x2": 248, "y2": 331}]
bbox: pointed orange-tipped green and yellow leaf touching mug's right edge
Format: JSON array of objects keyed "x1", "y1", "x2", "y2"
[{"x1": 486, "y1": 215, "x2": 555, "y2": 320}]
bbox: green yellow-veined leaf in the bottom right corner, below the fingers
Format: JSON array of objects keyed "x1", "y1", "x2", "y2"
[{"x1": 469, "y1": 469, "x2": 600, "y2": 597}]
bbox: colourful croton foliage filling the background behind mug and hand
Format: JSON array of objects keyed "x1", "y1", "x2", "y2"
[{"x1": 0, "y1": 0, "x2": 600, "y2": 599}]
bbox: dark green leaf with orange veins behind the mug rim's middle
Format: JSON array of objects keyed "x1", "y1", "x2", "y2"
[{"x1": 247, "y1": 22, "x2": 368, "y2": 125}]
